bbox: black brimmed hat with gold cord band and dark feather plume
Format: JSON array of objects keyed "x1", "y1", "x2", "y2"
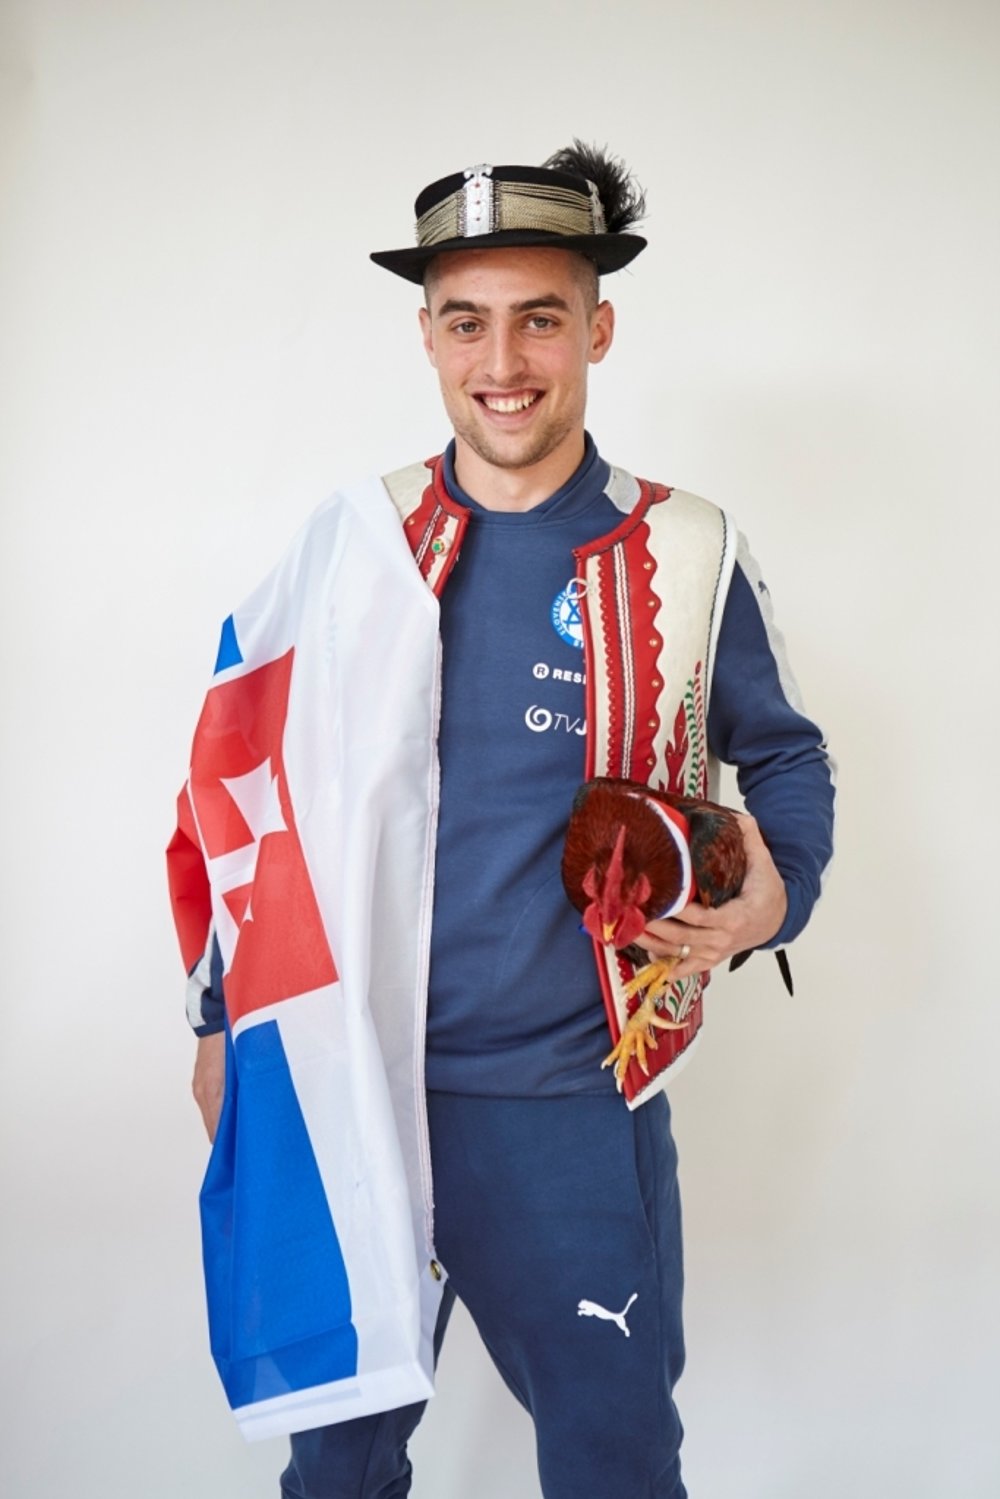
[{"x1": 372, "y1": 141, "x2": 646, "y2": 286}]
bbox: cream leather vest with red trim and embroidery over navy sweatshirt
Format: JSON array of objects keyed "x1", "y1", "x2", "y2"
[{"x1": 382, "y1": 459, "x2": 736, "y2": 1108}]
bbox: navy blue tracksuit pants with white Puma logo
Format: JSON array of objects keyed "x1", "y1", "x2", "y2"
[{"x1": 282, "y1": 1093, "x2": 685, "y2": 1499}]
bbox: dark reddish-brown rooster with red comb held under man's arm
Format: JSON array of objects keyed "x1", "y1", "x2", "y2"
[{"x1": 562, "y1": 778, "x2": 747, "y2": 1090}]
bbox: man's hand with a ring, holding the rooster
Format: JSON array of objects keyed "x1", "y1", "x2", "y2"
[{"x1": 639, "y1": 814, "x2": 789, "y2": 979}]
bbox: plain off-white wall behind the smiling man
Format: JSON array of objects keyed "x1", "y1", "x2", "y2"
[{"x1": 0, "y1": 0, "x2": 1000, "y2": 1499}]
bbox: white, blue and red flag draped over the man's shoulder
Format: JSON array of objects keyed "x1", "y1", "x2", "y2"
[{"x1": 168, "y1": 480, "x2": 442, "y2": 1438}]
